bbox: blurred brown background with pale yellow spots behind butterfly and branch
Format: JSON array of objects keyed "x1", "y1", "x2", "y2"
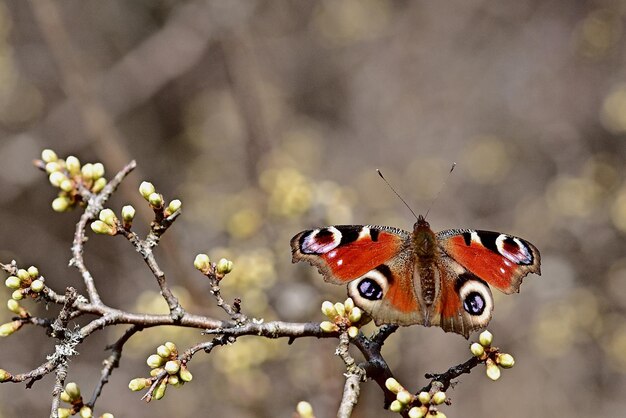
[{"x1": 0, "y1": 0, "x2": 626, "y2": 417}]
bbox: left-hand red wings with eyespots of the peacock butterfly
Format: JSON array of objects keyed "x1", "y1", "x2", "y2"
[{"x1": 291, "y1": 225, "x2": 422, "y2": 325}]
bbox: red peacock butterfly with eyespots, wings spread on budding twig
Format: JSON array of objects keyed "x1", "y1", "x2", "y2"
[{"x1": 291, "y1": 215, "x2": 541, "y2": 338}]
